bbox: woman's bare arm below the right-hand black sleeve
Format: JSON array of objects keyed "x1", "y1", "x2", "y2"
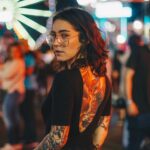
[{"x1": 93, "y1": 116, "x2": 111, "y2": 149}]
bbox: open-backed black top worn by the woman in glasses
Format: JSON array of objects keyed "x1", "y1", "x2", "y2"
[{"x1": 42, "y1": 69, "x2": 111, "y2": 150}]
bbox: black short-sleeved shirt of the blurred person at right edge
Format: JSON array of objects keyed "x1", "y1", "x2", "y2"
[{"x1": 127, "y1": 45, "x2": 150, "y2": 113}]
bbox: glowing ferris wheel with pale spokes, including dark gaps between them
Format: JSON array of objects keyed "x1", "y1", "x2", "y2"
[{"x1": 0, "y1": 0, "x2": 52, "y2": 47}]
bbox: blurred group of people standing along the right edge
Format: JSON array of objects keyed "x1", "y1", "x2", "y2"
[{"x1": 112, "y1": 32, "x2": 150, "y2": 150}]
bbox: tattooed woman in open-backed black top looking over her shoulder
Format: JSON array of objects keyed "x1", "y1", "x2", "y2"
[{"x1": 36, "y1": 8, "x2": 110, "y2": 150}]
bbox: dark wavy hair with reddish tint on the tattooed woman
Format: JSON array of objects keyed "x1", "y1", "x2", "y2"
[{"x1": 53, "y1": 8, "x2": 108, "y2": 76}]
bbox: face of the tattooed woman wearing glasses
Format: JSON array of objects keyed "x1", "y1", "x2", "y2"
[{"x1": 50, "y1": 19, "x2": 81, "y2": 61}]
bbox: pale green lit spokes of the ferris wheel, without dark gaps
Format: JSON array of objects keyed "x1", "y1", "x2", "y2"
[{"x1": 0, "y1": 0, "x2": 52, "y2": 48}]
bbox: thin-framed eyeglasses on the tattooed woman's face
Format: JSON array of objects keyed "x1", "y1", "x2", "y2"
[{"x1": 46, "y1": 34, "x2": 78, "y2": 47}]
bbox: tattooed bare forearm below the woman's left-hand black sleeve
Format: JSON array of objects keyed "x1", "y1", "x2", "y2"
[{"x1": 35, "y1": 126, "x2": 70, "y2": 150}]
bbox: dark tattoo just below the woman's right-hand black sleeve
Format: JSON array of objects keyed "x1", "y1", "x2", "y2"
[{"x1": 97, "y1": 116, "x2": 110, "y2": 130}]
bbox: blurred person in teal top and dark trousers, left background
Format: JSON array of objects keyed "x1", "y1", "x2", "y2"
[{"x1": 20, "y1": 39, "x2": 37, "y2": 148}]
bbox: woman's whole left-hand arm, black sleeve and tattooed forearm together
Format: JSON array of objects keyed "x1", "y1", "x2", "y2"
[{"x1": 35, "y1": 72, "x2": 74, "y2": 150}]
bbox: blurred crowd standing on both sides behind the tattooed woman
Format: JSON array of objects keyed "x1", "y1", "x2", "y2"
[{"x1": 0, "y1": 29, "x2": 150, "y2": 150}]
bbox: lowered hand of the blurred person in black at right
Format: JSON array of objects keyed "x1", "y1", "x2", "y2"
[{"x1": 127, "y1": 100, "x2": 139, "y2": 116}]
